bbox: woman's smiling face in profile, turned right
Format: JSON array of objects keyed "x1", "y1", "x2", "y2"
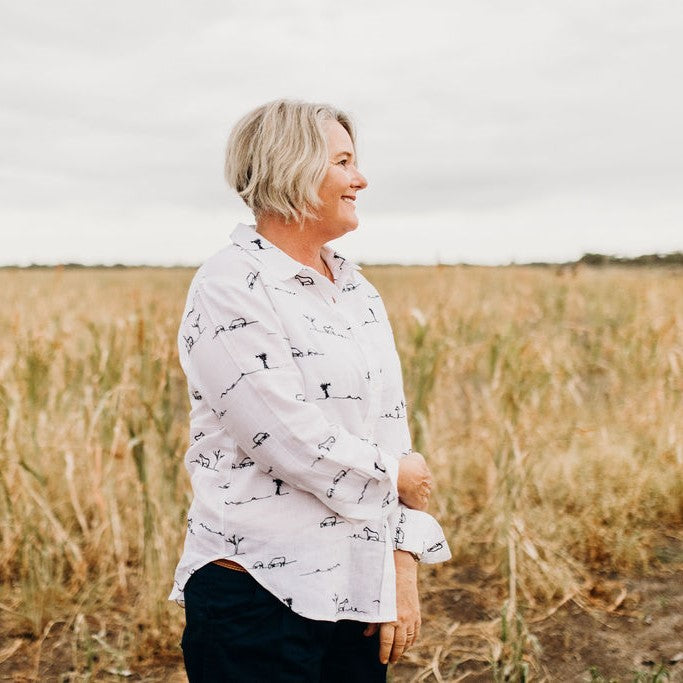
[{"x1": 316, "y1": 121, "x2": 368, "y2": 240}]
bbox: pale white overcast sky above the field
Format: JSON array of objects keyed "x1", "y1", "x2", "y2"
[{"x1": 0, "y1": 0, "x2": 683, "y2": 264}]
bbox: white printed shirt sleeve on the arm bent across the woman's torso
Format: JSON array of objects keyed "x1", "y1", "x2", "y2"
[{"x1": 178, "y1": 276, "x2": 398, "y2": 519}]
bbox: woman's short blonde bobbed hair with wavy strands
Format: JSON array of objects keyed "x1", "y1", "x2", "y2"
[{"x1": 225, "y1": 100, "x2": 356, "y2": 221}]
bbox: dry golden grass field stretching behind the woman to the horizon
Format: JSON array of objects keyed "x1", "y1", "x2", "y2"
[{"x1": 0, "y1": 267, "x2": 683, "y2": 683}]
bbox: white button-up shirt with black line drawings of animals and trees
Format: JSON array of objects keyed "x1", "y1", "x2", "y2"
[{"x1": 170, "y1": 224, "x2": 450, "y2": 622}]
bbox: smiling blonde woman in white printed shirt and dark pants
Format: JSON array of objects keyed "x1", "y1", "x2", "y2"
[{"x1": 171, "y1": 100, "x2": 450, "y2": 682}]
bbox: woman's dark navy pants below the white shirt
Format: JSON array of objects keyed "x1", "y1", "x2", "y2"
[{"x1": 182, "y1": 564, "x2": 386, "y2": 683}]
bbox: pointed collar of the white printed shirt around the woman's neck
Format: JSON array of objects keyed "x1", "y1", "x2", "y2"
[{"x1": 230, "y1": 223, "x2": 361, "y2": 285}]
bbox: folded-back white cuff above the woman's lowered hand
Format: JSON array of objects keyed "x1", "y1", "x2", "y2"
[{"x1": 389, "y1": 505, "x2": 451, "y2": 564}]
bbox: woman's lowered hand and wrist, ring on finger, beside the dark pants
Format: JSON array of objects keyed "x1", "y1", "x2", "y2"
[{"x1": 363, "y1": 550, "x2": 422, "y2": 664}]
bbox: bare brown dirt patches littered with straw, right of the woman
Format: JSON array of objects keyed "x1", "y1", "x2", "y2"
[{"x1": 393, "y1": 565, "x2": 683, "y2": 683}]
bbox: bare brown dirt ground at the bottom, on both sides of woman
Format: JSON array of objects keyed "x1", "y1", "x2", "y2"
[{"x1": 0, "y1": 564, "x2": 683, "y2": 683}]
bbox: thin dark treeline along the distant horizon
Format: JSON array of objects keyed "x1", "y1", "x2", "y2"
[{"x1": 0, "y1": 251, "x2": 683, "y2": 270}]
